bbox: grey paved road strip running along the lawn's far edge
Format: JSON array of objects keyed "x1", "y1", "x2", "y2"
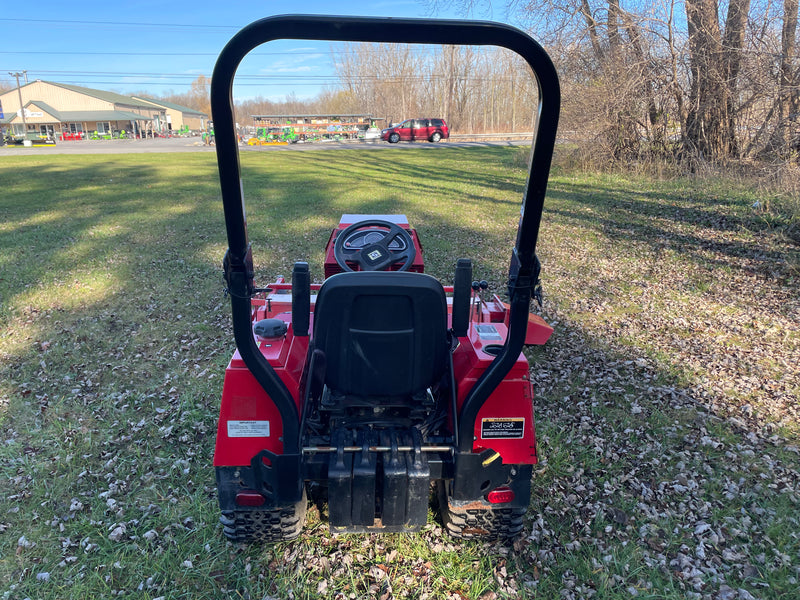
[{"x1": 0, "y1": 138, "x2": 530, "y2": 156}]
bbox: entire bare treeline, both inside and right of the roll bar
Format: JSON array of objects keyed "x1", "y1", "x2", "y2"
[{"x1": 162, "y1": 0, "x2": 800, "y2": 161}]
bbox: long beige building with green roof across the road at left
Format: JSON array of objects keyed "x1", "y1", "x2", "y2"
[{"x1": 0, "y1": 80, "x2": 205, "y2": 139}]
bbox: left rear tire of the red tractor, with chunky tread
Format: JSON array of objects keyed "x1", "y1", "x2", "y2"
[{"x1": 219, "y1": 488, "x2": 308, "y2": 543}]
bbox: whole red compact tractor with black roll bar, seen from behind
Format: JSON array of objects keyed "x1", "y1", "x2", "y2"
[{"x1": 211, "y1": 16, "x2": 560, "y2": 542}]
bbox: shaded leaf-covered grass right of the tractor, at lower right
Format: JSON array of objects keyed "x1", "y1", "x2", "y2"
[{"x1": 515, "y1": 311, "x2": 800, "y2": 599}]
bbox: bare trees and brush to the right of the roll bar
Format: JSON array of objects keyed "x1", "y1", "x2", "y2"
[{"x1": 422, "y1": 0, "x2": 800, "y2": 160}]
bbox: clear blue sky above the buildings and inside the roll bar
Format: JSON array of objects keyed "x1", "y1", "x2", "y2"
[{"x1": 0, "y1": 0, "x2": 488, "y2": 100}]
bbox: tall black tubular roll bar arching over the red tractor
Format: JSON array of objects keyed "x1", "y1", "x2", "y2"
[{"x1": 211, "y1": 15, "x2": 561, "y2": 453}]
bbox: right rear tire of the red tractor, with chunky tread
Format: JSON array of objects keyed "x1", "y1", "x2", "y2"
[{"x1": 437, "y1": 481, "x2": 527, "y2": 540}]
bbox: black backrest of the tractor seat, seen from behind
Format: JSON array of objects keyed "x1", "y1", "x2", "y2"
[{"x1": 313, "y1": 271, "x2": 450, "y2": 398}]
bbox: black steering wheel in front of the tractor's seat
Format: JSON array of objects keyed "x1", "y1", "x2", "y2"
[{"x1": 333, "y1": 219, "x2": 417, "y2": 271}]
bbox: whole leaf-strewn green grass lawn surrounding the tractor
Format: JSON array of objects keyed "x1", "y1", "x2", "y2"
[{"x1": 0, "y1": 146, "x2": 800, "y2": 600}]
